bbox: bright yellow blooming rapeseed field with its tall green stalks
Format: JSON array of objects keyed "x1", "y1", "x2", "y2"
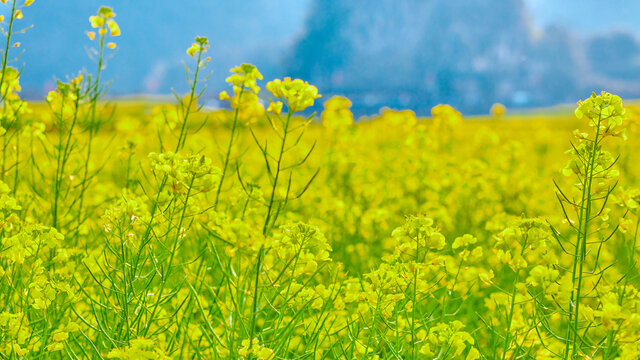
[{"x1": 0, "y1": 1, "x2": 640, "y2": 360}]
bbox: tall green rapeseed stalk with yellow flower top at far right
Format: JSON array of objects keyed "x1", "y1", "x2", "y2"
[{"x1": 554, "y1": 92, "x2": 624, "y2": 359}]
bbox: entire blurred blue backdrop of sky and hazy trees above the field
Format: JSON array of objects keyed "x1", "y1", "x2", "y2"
[{"x1": 11, "y1": 0, "x2": 640, "y2": 115}]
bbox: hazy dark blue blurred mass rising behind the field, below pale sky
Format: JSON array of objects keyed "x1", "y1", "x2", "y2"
[{"x1": 287, "y1": 0, "x2": 640, "y2": 113}]
